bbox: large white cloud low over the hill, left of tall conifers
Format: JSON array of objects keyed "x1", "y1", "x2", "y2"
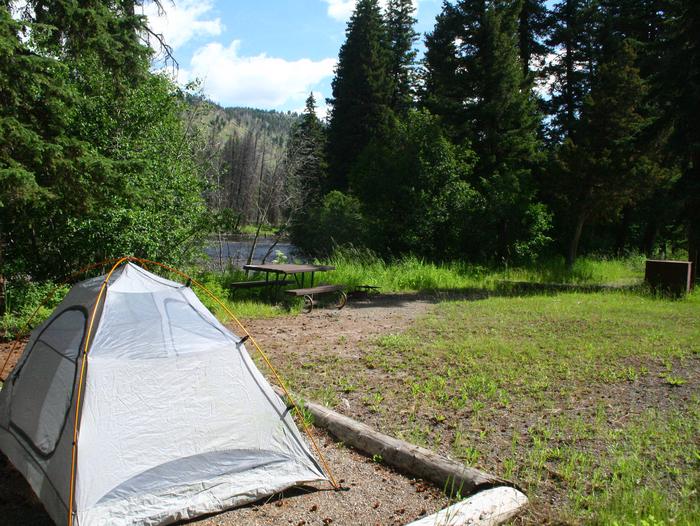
[{"x1": 180, "y1": 40, "x2": 336, "y2": 109}]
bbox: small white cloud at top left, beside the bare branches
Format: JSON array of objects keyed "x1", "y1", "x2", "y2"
[{"x1": 143, "y1": 0, "x2": 224, "y2": 49}]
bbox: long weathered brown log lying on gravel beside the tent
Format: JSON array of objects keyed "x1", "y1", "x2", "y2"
[{"x1": 278, "y1": 391, "x2": 514, "y2": 497}]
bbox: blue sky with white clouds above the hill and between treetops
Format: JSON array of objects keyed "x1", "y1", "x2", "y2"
[{"x1": 145, "y1": 0, "x2": 442, "y2": 114}]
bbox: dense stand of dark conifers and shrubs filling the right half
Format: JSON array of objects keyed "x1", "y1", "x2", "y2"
[{"x1": 299, "y1": 0, "x2": 700, "y2": 265}]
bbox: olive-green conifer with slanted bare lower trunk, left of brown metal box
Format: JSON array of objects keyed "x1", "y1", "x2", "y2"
[{"x1": 557, "y1": 39, "x2": 663, "y2": 265}]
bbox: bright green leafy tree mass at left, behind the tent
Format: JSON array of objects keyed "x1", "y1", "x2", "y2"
[{"x1": 0, "y1": 2, "x2": 208, "y2": 279}]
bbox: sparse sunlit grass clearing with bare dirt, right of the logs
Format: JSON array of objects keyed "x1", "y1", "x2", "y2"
[{"x1": 272, "y1": 293, "x2": 700, "y2": 526}]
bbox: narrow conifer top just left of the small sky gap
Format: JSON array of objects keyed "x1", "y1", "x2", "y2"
[{"x1": 386, "y1": 0, "x2": 418, "y2": 116}]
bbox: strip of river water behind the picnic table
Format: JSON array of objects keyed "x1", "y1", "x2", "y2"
[{"x1": 204, "y1": 237, "x2": 308, "y2": 268}]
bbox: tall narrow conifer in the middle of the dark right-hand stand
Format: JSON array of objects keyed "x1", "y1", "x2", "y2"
[{"x1": 471, "y1": 6, "x2": 542, "y2": 258}]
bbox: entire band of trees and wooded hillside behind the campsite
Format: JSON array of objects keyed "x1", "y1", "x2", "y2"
[{"x1": 0, "y1": 0, "x2": 700, "y2": 296}]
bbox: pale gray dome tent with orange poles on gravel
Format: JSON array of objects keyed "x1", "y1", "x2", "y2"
[{"x1": 0, "y1": 262, "x2": 328, "y2": 526}]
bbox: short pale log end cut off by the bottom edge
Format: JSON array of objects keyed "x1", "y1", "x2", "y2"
[{"x1": 407, "y1": 486, "x2": 527, "y2": 526}]
